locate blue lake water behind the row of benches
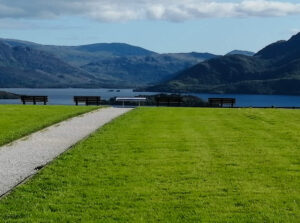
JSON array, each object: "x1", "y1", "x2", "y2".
[{"x1": 0, "y1": 88, "x2": 300, "y2": 107}]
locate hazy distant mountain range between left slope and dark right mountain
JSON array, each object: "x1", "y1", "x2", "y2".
[{"x1": 0, "y1": 39, "x2": 216, "y2": 88}]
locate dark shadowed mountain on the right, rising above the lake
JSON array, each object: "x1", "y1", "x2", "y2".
[{"x1": 146, "y1": 33, "x2": 300, "y2": 95}]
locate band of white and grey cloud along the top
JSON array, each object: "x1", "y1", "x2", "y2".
[{"x1": 0, "y1": 0, "x2": 300, "y2": 22}]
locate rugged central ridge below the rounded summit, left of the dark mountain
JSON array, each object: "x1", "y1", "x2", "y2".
[{"x1": 81, "y1": 53, "x2": 216, "y2": 86}]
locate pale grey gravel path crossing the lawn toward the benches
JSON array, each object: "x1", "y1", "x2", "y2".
[{"x1": 0, "y1": 108, "x2": 131, "y2": 197}]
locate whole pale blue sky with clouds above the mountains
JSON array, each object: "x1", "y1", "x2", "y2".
[{"x1": 0, "y1": 0, "x2": 300, "y2": 54}]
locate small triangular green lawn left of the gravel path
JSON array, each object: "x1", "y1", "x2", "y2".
[{"x1": 0, "y1": 105, "x2": 96, "y2": 146}]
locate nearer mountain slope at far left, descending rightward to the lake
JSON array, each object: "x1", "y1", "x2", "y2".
[{"x1": 0, "y1": 41, "x2": 115, "y2": 87}]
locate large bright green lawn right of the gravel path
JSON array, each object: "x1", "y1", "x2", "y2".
[{"x1": 0, "y1": 108, "x2": 300, "y2": 222}]
